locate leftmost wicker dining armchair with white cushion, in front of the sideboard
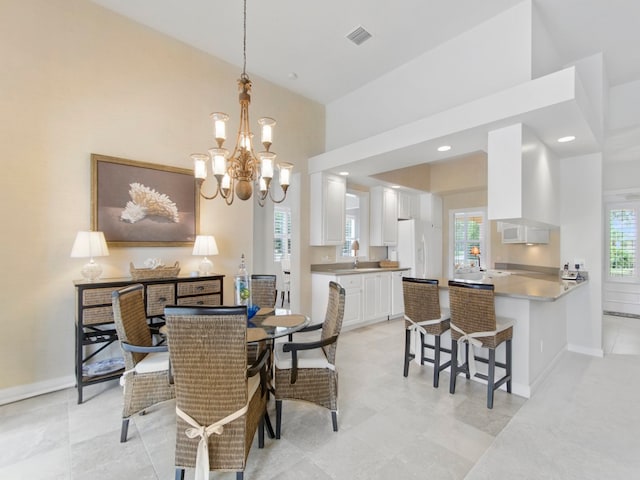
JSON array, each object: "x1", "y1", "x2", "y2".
[{"x1": 111, "y1": 283, "x2": 175, "y2": 442}]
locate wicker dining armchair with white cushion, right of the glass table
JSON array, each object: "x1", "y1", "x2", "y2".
[{"x1": 274, "y1": 282, "x2": 345, "y2": 438}]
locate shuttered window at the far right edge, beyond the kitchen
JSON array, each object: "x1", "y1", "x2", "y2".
[{"x1": 607, "y1": 204, "x2": 640, "y2": 279}]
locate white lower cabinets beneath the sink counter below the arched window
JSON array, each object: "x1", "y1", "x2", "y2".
[{"x1": 311, "y1": 272, "x2": 396, "y2": 330}]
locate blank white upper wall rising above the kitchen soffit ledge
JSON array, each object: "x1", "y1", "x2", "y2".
[{"x1": 326, "y1": 0, "x2": 532, "y2": 150}]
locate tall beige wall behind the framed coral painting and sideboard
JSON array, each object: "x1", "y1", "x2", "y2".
[{"x1": 0, "y1": 0, "x2": 324, "y2": 400}]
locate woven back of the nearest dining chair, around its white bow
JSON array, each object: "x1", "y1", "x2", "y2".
[{"x1": 165, "y1": 306, "x2": 250, "y2": 469}]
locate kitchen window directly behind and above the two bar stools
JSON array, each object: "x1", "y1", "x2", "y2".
[{"x1": 452, "y1": 210, "x2": 486, "y2": 268}]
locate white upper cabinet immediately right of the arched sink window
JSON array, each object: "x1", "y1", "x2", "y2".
[{"x1": 369, "y1": 187, "x2": 398, "y2": 247}]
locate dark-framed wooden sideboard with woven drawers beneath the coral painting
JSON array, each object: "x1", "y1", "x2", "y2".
[{"x1": 74, "y1": 274, "x2": 224, "y2": 403}]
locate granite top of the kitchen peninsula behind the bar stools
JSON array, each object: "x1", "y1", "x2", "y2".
[{"x1": 440, "y1": 271, "x2": 588, "y2": 302}]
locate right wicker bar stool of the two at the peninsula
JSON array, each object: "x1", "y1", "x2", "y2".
[{"x1": 449, "y1": 280, "x2": 513, "y2": 408}]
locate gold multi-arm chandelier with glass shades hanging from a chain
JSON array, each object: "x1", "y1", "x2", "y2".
[{"x1": 191, "y1": 0, "x2": 293, "y2": 207}]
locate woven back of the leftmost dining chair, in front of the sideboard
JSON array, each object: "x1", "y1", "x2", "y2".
[{"x1": 111, "y1": 283, "x2": 153, "y2": 370}]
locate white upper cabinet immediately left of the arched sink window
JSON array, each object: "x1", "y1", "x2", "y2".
[{"x1": 309, "y1": 172, "x2": 347, "y2": 246}]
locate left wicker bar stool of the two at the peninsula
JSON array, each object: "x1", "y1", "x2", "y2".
[{"x1": 402, "y1": 277, "x2": 451, "y2": 388}]
